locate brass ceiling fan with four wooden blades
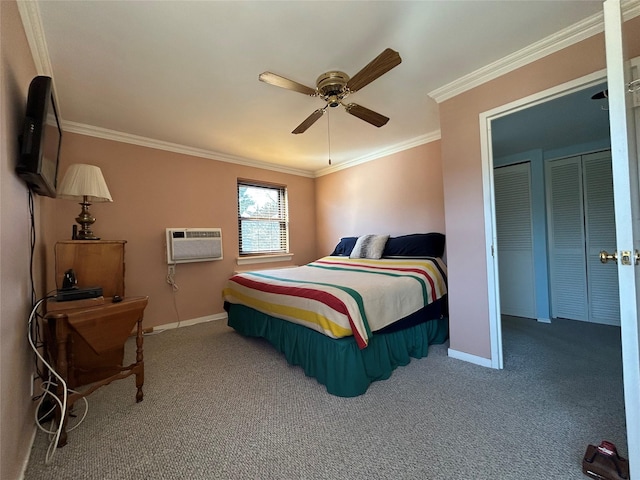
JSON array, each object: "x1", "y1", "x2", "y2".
[{"x1": 258, "y1": 48, "x2": 402, "y2": 134}]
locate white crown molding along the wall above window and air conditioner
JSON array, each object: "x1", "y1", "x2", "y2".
[{"x1": 61, "y1": 120, "x2": 314, "y2": 178}]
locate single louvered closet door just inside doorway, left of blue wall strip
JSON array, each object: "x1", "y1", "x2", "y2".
[{"x1": 493, "y1": 163, "x2": 536, "y2": 318}]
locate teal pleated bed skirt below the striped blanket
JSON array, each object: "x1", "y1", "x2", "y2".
[{"x1": 228, "y1": 304, "x2": 449, "y2": 397}]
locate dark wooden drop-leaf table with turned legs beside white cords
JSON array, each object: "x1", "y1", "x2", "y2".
[{"x1": 45, "y1": 297, "x2": 149, "y2": 447}]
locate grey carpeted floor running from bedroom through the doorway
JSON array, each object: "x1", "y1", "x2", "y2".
[{"x1": 25, "y1": 318, "x2": 627, "y2": 480}]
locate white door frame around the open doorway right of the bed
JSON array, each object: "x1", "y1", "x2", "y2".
[{"x1": 479, "y1": 69, "x2": 607, "y2": 369}]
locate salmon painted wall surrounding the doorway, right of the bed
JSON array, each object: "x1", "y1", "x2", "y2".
[{"x1": 440, "y1": 17, "x2": 640, "y2": 359}]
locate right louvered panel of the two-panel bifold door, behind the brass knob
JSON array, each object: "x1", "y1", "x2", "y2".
[{"x1": 582, "y1": 151, "x2": 620, "y2": 325}]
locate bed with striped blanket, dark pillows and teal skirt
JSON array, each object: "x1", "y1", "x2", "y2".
[{"x1": 222, "y1": 233, "x2": 448, "y2": 397}]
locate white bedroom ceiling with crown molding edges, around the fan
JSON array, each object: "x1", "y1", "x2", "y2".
[{"x1": 19, "y1": 0, "x2": 616, "y2": 175}]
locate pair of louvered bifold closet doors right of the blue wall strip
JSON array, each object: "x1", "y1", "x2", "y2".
[{"x1": 544, "y1": 150, "x2": 620, "y2": 326}]
